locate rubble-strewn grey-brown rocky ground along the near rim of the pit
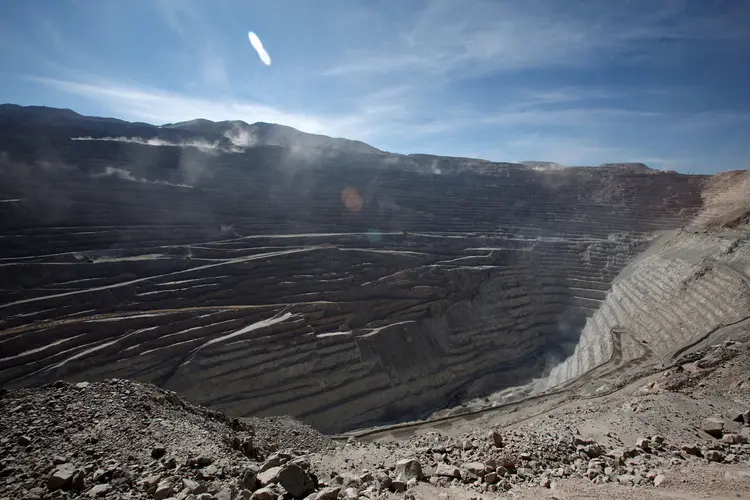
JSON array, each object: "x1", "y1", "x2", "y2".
[{"x1": 0, "y1": 329, "x2": 750, "y2": 500}]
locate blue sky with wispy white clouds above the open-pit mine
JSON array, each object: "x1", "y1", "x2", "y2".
[{"x1": 0, "y1": 0, "x2": 750, "y2": 172}]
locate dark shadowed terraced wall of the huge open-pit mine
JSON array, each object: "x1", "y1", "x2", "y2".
[{"x1": 0, "y1": 111, "x2": 704, "y2": 432}]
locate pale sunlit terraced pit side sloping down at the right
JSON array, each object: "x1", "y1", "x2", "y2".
[{"x1": 542, "y1": 171, "x2": 750, "y2": 389}]
